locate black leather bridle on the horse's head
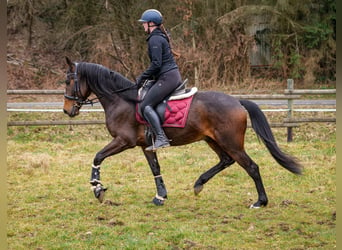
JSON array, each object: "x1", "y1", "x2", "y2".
[{"x1": 64, "y1": 63, "x2": 99, "y2": 108}]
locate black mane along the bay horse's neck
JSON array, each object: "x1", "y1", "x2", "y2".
[{"x1": 77, "y1": 62, "x2": 138, "y2": 102}]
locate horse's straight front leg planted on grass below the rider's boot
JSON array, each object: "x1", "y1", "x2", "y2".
[{"x1": 143, "y1": 149, "x2": 167, "y2": 206}]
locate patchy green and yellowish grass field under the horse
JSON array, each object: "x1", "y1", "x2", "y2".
[{"x1": 7, "y1": 112, "x2": 336, "y2": 249}]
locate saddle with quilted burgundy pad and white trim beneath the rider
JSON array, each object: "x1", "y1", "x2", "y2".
[{"x1": 136, "y1": 79, "x2": 197, "y2": 127}]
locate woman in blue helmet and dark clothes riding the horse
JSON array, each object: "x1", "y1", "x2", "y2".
[{"x1": 137, "y1": 9, "x2": 182, "y2": 151}]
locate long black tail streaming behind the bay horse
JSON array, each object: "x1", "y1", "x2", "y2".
[{"x1": 239, "y1": 100, "x2": 303, "y2": 174}]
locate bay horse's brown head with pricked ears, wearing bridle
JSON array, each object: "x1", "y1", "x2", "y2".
[{"x1": 63, "y1": 57, "x2": 91, "y2": 117}]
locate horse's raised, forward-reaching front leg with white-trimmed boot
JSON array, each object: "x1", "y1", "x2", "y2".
[{"x1": 90, "y1": 136, "x2": 135, "y2": 202}]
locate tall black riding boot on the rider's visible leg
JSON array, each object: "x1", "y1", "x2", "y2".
[{"x1": 144, "y1": 106, "x2": 170, "y2": 151}]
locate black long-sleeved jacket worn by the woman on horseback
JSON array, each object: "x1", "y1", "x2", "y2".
[{"x1": 138, "y1": 28, "x2": 178, "y2": 83}]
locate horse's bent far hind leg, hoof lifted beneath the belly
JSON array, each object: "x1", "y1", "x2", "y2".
[{"x1": 194, "y1": 139, "x2": 235, "y2": 195}]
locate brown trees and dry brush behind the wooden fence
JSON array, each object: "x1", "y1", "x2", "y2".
[{"x1": 7, "y1": 0, "x2": 336, "y2": 88}]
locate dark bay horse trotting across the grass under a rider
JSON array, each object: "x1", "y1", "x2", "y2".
[{"x1": 64, "y1": 58, "x2": 302, "y2": 208}]
